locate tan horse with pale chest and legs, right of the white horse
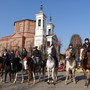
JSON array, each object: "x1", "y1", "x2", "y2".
[{"x1": 65, "y1": 50, "x2": 76, "y2": 84}]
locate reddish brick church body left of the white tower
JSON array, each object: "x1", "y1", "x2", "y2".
[{"x1": 0, "y1": 19, "x2": 36, "y2": 51}]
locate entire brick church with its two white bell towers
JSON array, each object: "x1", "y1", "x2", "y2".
[{"x1": 0, "y1": 5, "x2": 59, "y2": 58}]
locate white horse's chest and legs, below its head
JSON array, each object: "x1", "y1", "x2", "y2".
[{"x1": 46, "y1": 55, "x2": 57, "y2": 83}]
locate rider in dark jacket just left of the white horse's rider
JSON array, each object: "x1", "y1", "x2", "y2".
[{"x1": 32, "y1": 46, "x2": 42, "y2": 64}]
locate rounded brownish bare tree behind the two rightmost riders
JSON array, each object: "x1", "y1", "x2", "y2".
[{"x1": 70, "y1": 34, "x2": 82, "y2": 59}]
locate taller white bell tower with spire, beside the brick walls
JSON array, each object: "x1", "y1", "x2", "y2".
[{"x1": 34, "y1": 4, "x2": 46, "y2": 47}]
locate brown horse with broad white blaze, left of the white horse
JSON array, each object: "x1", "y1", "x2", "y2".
[{"x1": 22, "y1": 56, "x2": 46, "y2": 84}]
